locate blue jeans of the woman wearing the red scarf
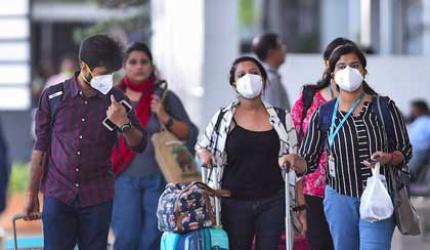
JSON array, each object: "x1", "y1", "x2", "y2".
[{"x1": 112, "y1": 174, "x2": 165, "y2": 250}]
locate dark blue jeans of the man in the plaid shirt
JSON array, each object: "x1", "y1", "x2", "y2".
[{"x1": 42, "y1": 196, "x2": 112, "y2": 250}]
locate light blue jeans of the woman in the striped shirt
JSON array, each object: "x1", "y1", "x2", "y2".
[{"x1": 324, "y1": 185, "x2": 395, "y2": 250}]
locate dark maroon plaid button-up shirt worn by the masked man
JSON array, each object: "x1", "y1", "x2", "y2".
[{"x1": 35, "y1": 74, "x2": 146, "y2": 207}]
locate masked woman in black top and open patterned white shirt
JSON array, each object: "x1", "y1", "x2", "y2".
[{"x1": 196, "y1": 56, "x2": 306, "y2": 250}]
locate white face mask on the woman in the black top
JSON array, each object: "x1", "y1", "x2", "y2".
[{"x1": 236, "y1": 74, "x2": 263, "y2": 99}]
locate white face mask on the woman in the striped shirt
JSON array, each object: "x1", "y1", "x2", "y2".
[{"x1": 334, "y1": 66, "x2": 364, "y2": 92}]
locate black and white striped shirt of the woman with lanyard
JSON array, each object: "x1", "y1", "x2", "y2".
[{"x1": 299, "y1": 97, "x2": 412, "y2": 197}]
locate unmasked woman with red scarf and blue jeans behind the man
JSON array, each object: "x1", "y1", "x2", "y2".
[{"x1": 112, "y1": 42, "x2": 197, "y2": 250}]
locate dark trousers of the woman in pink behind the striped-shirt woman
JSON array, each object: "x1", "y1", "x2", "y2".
[{"x1": 305, "y1": 195, "x2": 334, "y2": 250}]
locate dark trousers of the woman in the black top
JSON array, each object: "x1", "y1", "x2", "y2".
[{"x1": 222, "y1": 192, "x2": 285, "y2": 250}]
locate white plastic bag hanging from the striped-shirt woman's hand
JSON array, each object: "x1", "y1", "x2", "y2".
[{"x1": 360, "y1": 163, "x2": 394, "y2": 222}]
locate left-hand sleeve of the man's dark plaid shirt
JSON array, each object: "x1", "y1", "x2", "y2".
[{"x1": 34, "y1": 90, "x2": 51, "y2": 152}]
